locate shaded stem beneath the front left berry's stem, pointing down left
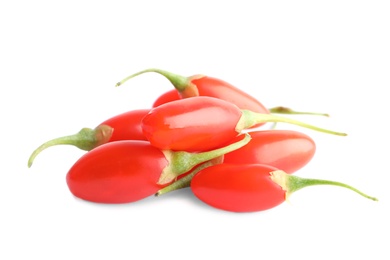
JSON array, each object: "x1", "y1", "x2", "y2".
[{"x1": 155, "y1": 156, "x2": 223, "y2": 196}]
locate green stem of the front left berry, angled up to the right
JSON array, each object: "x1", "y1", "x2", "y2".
[{"x1": 158, "y1": 134, "x2": 251, "y2": 184}]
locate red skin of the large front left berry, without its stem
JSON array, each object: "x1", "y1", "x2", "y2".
[{"x1": 66, "y1": 140, "x2": 168, "y2": 203}]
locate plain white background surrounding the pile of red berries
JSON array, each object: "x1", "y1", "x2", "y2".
[{"x1": 0, "y1": 0, "x2": 390, "y2": 260}]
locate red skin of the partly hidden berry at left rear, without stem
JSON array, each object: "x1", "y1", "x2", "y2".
[{"x1": 100, "y1": 109, "x2": 150, "y2": 142}]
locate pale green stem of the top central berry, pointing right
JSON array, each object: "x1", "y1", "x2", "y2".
[{"x1": 236, "y1": 109, "x2": 347, "y2": 136}]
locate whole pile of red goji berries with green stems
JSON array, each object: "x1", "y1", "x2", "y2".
[{"x1": 28, "y1": 69, "x2": 377, "y2": 212}]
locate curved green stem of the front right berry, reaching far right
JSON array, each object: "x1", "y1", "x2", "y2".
[{"x1": 271, "y1": 171, "x2": 378, "y2": 201}]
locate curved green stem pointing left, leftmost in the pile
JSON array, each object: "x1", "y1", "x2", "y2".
[{"x1": 28, "y1": 125, "x2": 113, "y2": 167}]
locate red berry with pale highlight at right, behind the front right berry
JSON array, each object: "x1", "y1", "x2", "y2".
[{"x1": 224, "y1": 130, "x2": 316, "y2": 174}]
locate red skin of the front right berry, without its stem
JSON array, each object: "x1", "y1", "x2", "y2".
[{"x1": 191, "y1": 163, "x2": 286, "y2": 212}]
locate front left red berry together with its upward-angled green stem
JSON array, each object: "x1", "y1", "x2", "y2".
[{"x1": 66, "y1": 135, "x2": 250, "y2": 203}]
